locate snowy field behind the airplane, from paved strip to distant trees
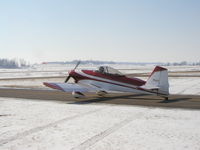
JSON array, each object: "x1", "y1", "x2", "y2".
[{"x1": 0, "y1": 64, "x2": 200, "y2": 95}]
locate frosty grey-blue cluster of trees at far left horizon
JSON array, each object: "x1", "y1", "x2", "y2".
[{"x1": 0, "y1": 58, "x2": 29, "y2": 69}]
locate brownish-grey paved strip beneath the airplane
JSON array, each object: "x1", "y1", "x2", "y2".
[{"x1": 0, "y1": 89, "x2": 200, "y2": 109}]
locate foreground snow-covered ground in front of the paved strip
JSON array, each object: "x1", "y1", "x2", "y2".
[{"x1": 0, "y1": 98, "x2": 200, "y2": 150}]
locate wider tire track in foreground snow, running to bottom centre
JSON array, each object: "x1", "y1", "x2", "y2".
[{"x1": 71, "y1": 113, "x2": 142, "y2": 150}]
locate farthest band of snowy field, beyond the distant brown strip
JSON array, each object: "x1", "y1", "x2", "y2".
[{"x1": 0, "y1": 64, "x2": 200, "y2": 79}]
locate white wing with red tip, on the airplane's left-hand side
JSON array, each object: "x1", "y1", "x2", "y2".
[{"x1": 43, "y1": 82, "x2": 96, "y2": 92}]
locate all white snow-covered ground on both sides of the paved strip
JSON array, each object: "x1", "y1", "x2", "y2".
[{"x1": 0, "y1": 65, "x2": 200, "y2": 150}]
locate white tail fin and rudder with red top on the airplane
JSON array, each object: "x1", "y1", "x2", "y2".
[{"x1": 145, "y1": 66, "x2": 169, "y2": 95}]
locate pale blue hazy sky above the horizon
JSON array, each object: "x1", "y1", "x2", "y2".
[{"x1": 0, "y1": 0, "x2": 200, "y2": 62}]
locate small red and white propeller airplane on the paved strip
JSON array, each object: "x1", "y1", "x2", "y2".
[{"x1": 43, "y1": 61, "x2": 169, "y2": 100}]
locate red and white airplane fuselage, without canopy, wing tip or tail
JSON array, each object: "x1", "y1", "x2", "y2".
[{"x1": 69, "y1": 70, "x2": 152, "y2": 93}]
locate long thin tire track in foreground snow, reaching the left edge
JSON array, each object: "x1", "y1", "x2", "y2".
[{"x1": 0, "y1": 107, "x2": 106, "y2": 146}]
